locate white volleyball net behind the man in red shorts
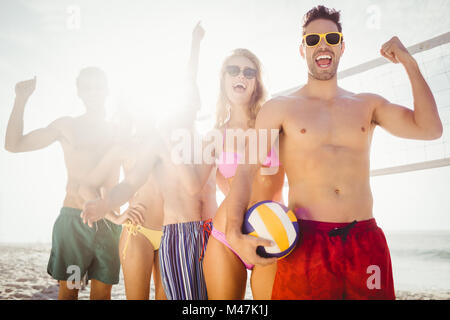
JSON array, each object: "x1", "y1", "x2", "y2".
[{"x1": 277, "y1": 32, "x2": 450, "y2": 176}]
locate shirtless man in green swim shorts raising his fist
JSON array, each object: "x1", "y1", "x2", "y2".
[{"x1": 5, "y1": 67, "x2": 125, "y2": 300}]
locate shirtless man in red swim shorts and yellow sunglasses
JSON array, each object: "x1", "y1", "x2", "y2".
[{"x1": 226, "y1": 6, "x2": 442, "y2": 299}]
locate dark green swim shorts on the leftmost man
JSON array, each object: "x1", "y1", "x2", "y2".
[{"x1": 47, "y1": 207, "x2": 122, "y2": 284}]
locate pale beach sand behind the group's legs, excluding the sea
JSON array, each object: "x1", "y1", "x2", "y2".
[{"x1": 0, "y1": 244, "x2": 450, "y2": 300}]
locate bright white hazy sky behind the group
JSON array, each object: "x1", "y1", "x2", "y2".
[{"x1": 0, "y1": 0, "x2": 450, "y2": 242}]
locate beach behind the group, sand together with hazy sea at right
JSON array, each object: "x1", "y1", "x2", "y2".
[{"x1": 0, "y1": 231, "x2": 450, "y2": 300}]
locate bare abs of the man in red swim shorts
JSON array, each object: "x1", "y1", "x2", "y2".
[{"x1": 285, "y1": 147, "x2": 373, "y2": 222}]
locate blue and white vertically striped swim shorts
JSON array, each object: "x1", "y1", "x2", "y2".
[{"x1": 159, "y1": 220, "x2": 212, "y2": 300}]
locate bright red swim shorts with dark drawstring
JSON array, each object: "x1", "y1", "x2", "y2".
[{"x1": 272, "y1": 219, "x2": 395, "y2": 300}]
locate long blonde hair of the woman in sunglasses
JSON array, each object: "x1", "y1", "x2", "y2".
[{"x1": 215, "y1": 48, "x2": 267, "y2": 128}]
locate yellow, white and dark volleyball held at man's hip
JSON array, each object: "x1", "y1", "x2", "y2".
[{"x1": 242, "y1": 201, "x2": 299, "y2": 259}]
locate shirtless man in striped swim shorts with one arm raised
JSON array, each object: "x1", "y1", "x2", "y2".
[{"x1": 82, "y1": 24, "x2": 217, "y2": 300}]
